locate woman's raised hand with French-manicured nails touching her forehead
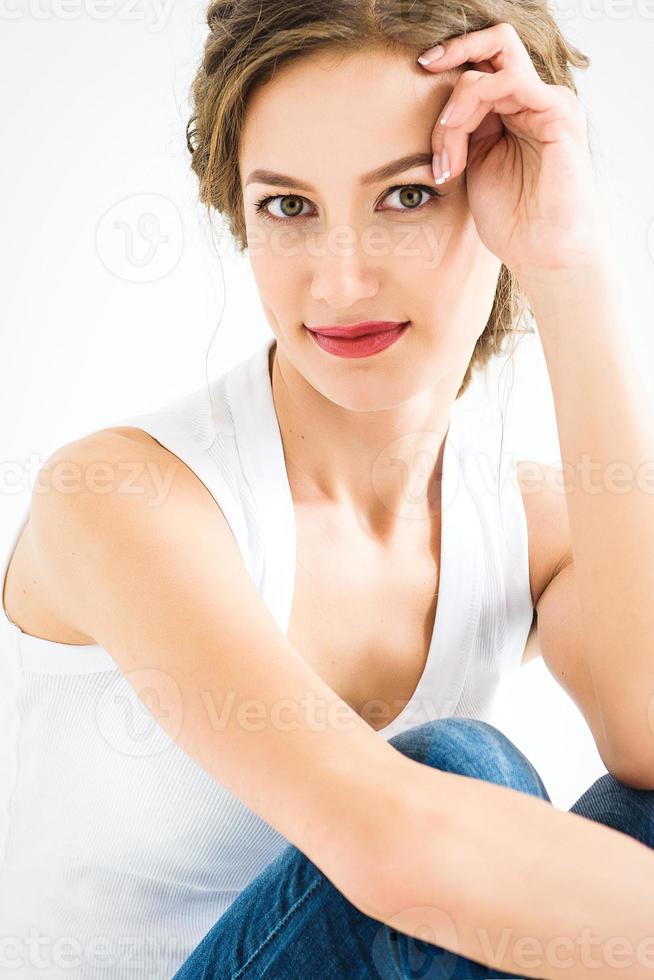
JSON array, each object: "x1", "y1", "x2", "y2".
[{"x1": 420, "y1": 23, "x2": 601, "y2": 279}]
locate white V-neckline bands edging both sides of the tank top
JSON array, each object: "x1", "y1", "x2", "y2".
[{"x1": 227, "y1": 337, "x2": 482, "y2": 738}]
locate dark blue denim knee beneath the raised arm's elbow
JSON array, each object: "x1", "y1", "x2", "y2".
[{"x1": 570, "y1": 772, "x2": 654, "y2": 847}]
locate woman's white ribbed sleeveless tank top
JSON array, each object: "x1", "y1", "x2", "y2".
[{"x1": 0, "y1": 338, "x2": 533, "y2": 980}]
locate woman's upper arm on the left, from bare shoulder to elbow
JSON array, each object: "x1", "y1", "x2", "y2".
[{"x1": 30, "y1": 431, "x2": 403, "y2": 908}]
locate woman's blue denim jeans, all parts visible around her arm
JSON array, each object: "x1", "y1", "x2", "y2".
[{"x1": 173, "y1": 717, "x2": 654, "y2": 980}]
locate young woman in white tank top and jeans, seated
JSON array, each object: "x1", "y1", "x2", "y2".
[{"x1": 0, "y1": 0, "x2": 654, "y2": 980}]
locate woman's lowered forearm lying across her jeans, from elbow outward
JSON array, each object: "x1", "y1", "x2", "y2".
[{"x1": 376, "y1": 759, "x2": 654, "y2": 980}]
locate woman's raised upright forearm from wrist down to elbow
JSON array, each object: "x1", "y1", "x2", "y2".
[{"x1": 521, "y1": 255, "x2": 654, "y2": 789}]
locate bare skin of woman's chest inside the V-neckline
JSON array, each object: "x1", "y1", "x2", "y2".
[{"x1": 287, "y1": 512, "x2": 440, "y2": 730}]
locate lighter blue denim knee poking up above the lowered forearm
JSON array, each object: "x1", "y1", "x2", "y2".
[{"x1": 389, "y1": 717, "x2": 551, "y2": 802}]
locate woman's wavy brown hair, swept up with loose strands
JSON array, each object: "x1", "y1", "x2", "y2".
[{"x1": 186, "y1": 0, "x2": 590, "y2": 398}]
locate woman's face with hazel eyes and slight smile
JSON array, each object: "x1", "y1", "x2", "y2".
[{"x1": 239, "y1": 50, "x2": 501, "y2": 411}]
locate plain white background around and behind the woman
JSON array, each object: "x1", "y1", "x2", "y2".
[{"x1": 0, "y1": 0, "x2": 654, "y2": 807}]
